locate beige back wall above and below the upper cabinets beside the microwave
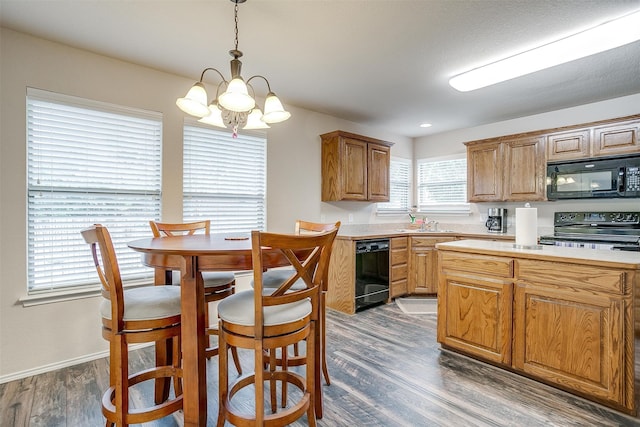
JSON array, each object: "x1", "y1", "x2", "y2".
[{"x1": 414, "y1": 93, "x2": 640, "y2": 231}]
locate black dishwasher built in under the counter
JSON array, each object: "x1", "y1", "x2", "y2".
[{"x1": 356, "y1": 239, "x2": 389, "y2": 311}]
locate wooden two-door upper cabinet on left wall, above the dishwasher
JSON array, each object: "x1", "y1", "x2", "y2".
[{"x1": 320, "y1": 131, "x2": 393, "y2": 202}]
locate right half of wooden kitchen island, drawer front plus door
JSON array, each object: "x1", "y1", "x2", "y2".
[{"x1": 513, "y1": 260, "x2": 633, "y2": 407}]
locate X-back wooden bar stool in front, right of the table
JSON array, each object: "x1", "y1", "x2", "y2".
[{"x1": 218, "y1": 229, "x2": 338, "y2": 427}]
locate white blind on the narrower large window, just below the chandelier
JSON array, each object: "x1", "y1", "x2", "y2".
[{"x1": 183, "y1": 125, "x2": 267, "y2": 233}]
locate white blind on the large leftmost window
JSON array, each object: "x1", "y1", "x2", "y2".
[{"x1": 27, "y1": 89, "x2": 162, "y2": 293}]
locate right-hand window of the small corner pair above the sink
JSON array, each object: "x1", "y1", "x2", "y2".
[{"x1": 418, "y1": 154, "x2": 470, "y2": 213}]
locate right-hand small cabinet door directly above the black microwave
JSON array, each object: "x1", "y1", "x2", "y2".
[{"x1": 592, "y1": 121, "x2": 640, "y2": 156}]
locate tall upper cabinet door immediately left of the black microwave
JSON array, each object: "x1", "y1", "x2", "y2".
[{"x1": 503, "y1": 137, "x2": 546, "y2": 201}]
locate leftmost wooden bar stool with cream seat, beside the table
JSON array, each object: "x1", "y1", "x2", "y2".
[{"x1": 82, "y1": 224, "x2": 182, "y2": 427}]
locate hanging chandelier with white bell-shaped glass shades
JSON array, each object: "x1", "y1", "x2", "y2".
[{"x1": 176, "y1": 0, "x2": 291, "y2": 138}]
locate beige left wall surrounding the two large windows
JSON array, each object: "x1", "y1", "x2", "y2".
[{"x1": 0, "y1": 28, "x2": 413, "y2": 382}]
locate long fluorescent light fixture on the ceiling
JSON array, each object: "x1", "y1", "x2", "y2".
[{"x1": 449, "y1": 11, "x2": 640, "y2": 92}]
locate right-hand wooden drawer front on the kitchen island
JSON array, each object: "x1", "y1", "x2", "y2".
[{"x1": 516, "y1": 259, "x2": 631, "y2": 294}]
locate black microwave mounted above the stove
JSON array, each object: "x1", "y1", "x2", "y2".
[{"x1": 547, "y1": 156, "x2": 640, "y2": 200}]
